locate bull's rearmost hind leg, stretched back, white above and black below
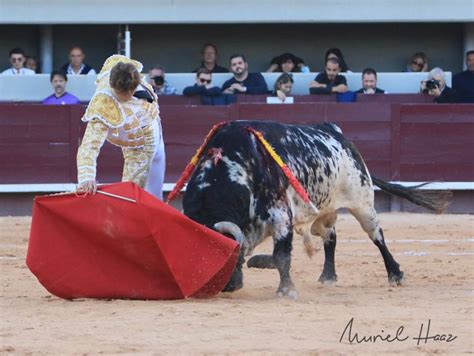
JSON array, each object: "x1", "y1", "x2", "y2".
[{"x1": 350, "y1": 207, "x2": 403, "y2": 285}]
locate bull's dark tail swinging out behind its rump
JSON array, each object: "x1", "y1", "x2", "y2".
[{"x1": 372, "y1": 176, "x2": 453, "y2": 214}]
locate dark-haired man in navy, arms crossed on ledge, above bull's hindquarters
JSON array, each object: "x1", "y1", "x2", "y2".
[{"x1": 309, "y1": 58, "x2": 347, "y2": 94}]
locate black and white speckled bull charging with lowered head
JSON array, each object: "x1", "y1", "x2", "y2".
[{"x1": 183, "y1": 121, "x2": 446, "y2": 298}]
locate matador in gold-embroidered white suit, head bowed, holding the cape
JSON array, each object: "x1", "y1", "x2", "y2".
[{"x1": 77, "y1": 55, "x2": 165, "y2": 199}]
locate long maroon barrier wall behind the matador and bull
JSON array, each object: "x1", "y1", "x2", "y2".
[{"x1": 0, "y1": 97, "x2": 474, "y2": 184}]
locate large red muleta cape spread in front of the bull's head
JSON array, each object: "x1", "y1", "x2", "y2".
[{"x1": 26, "y1": 182, "x2": 239, "y2": 299}]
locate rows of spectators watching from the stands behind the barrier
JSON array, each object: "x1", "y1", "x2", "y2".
[{"x1": 2, "y1": 43, "x2": 474, "y2": 105}]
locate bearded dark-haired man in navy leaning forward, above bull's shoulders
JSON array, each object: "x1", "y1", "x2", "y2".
[{"x1": 222, "y1": 54, "x2": 268, "y2": 94}]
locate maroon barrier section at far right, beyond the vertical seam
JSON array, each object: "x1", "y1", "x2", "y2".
[{"x1": 400, "y1": 105, "x2": 474, "y2": 181}]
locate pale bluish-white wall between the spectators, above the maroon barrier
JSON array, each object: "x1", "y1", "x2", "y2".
[{"x1": 0, "y1": 72, "x2": 452, "y2": 101}]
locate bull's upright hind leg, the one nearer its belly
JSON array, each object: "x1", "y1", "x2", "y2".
[{"x1": 311, "y1": 212, "x2": 337, "y2": 284}]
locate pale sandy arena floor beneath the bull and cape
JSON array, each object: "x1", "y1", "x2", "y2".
[{"x1": 0, "y1": 214, "x2": 474, "y2": 355}]
